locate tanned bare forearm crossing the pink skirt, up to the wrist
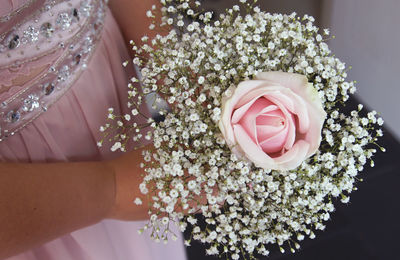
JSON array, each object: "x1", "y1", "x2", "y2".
[{"x1": 0, "y1": 162, "x2": 115, "y2": 259}]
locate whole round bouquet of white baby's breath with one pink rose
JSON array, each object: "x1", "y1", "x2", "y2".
[{"x1": 102, "y1": 0, "x2": 383, "y2": 259}]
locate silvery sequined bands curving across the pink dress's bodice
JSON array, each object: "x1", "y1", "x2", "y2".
[{"x1": 0, "y1": 0, "x2": 106, "y2": 141}]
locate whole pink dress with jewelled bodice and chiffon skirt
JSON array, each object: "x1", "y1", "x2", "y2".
[{"x1": 0, "y1": 0, "x2": 186, "y2": 260}]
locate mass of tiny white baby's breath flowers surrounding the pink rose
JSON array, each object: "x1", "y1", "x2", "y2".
[{"x1": 101, "y1": 0, "x2": 383, "y2": 259}]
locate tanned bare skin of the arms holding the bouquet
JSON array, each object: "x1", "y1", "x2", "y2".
[{"x1": 0, "y1": 0, "x2": 162, "y2": 259}]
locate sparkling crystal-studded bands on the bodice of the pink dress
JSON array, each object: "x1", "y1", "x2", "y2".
[{"x1": 0, "y1": 0, "x2": 105, "y2": 136}]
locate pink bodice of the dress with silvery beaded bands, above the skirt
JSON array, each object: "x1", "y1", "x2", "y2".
[{"x1": 0, "y1": 0, "x2": 106, "y2": 140}]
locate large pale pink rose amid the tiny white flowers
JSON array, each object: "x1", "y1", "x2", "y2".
[{"x1": 219, "y1": 72, "x2": 326, "y2": 170}]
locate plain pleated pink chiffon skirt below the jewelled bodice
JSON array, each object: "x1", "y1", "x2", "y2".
[{"x1": 0, "y1": 1, "x2": 186, "y2": 260}]
